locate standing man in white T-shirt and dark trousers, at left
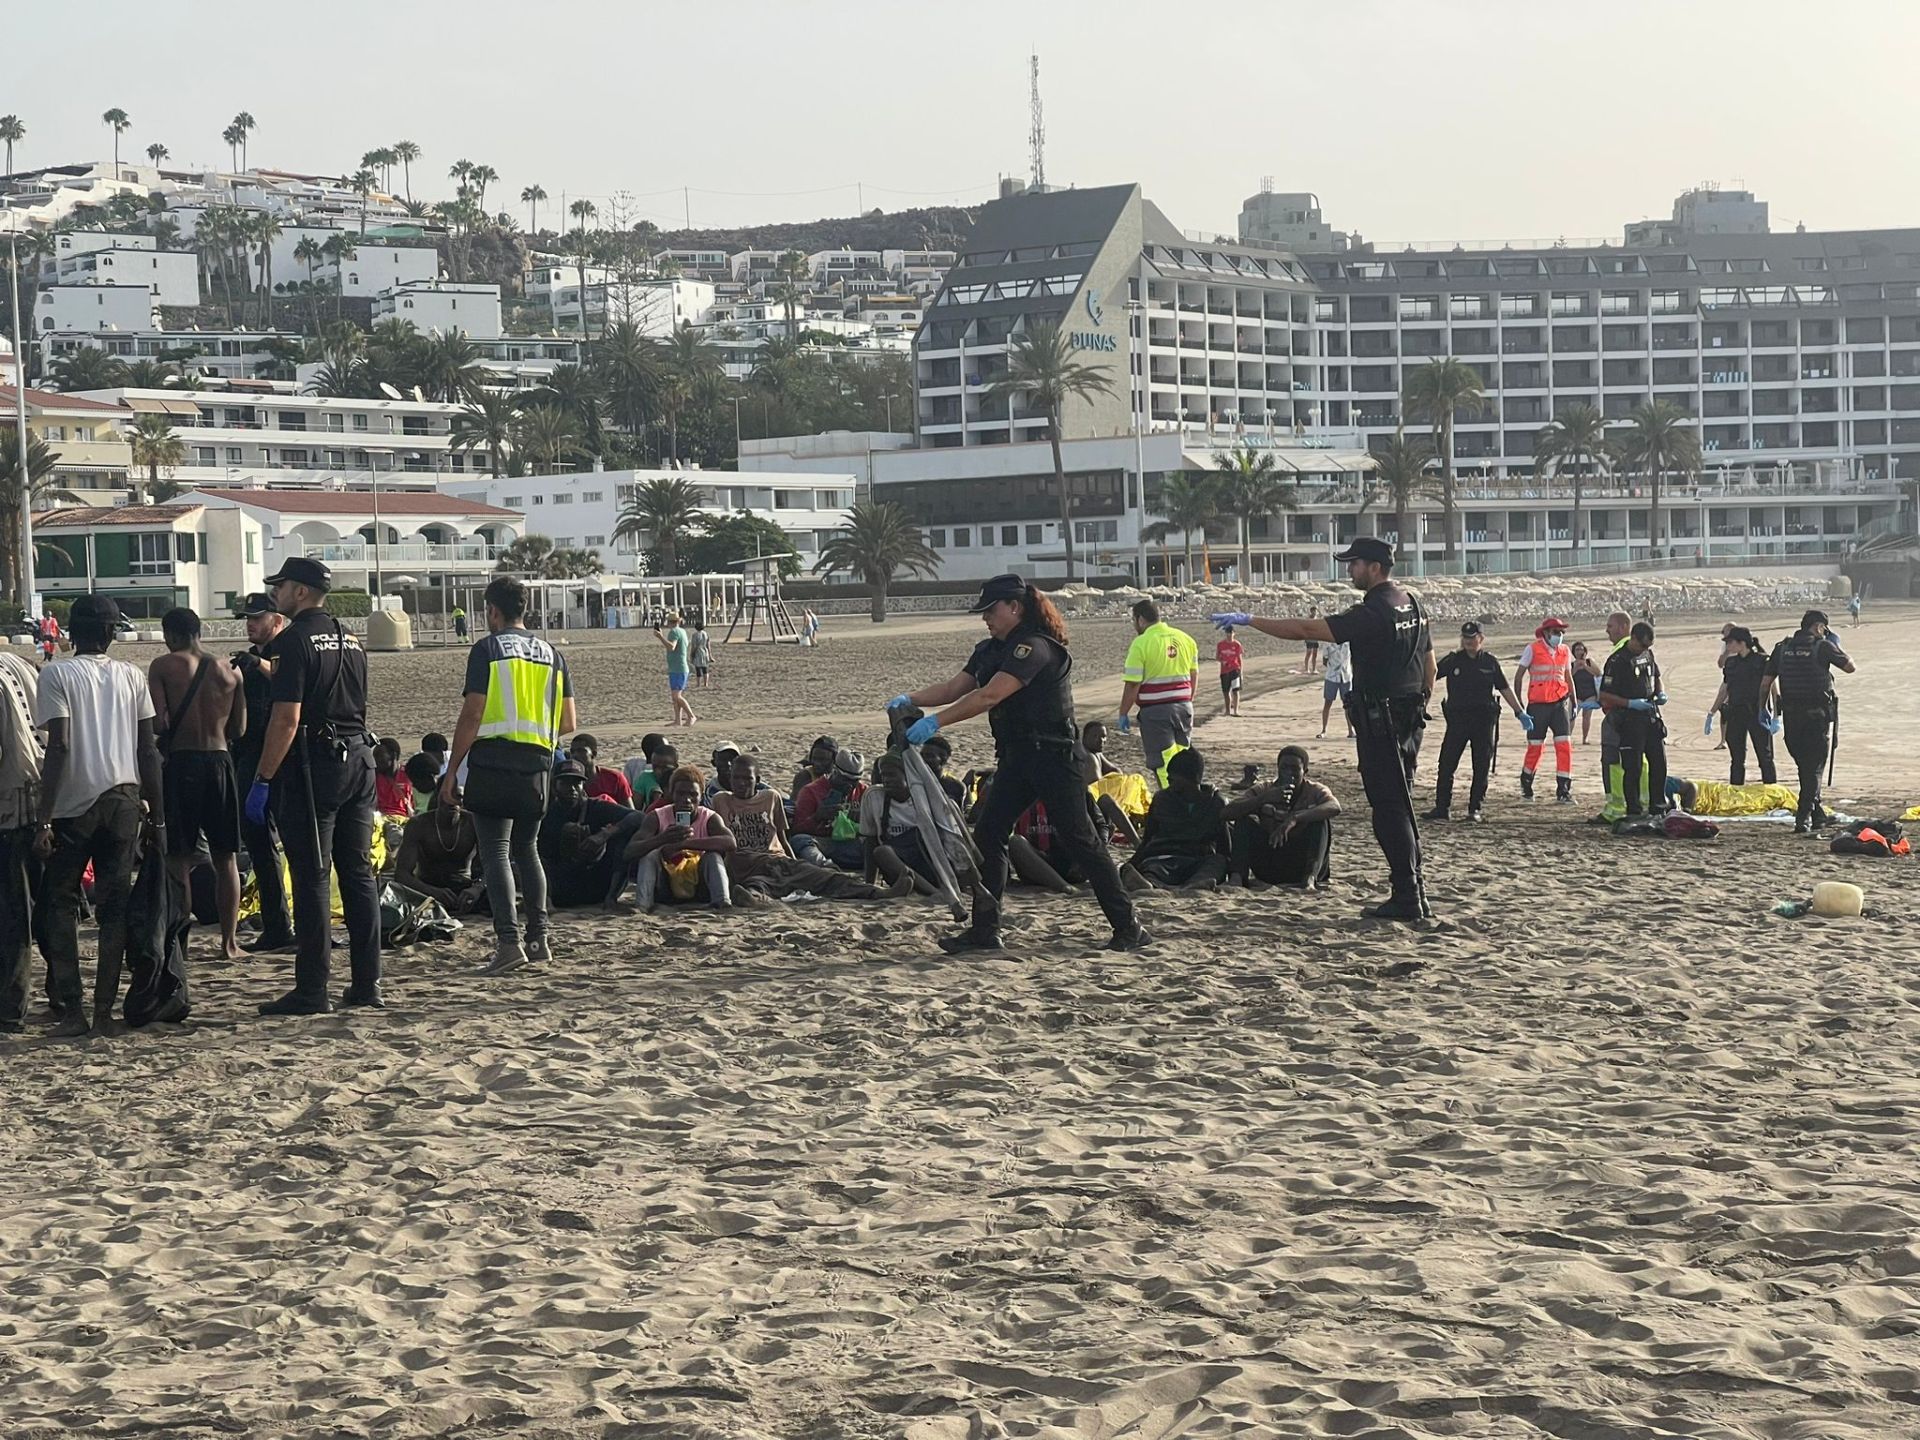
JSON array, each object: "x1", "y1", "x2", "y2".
[{"x1": 33, "y1": 595, "x2": 167, "y2": 1037}]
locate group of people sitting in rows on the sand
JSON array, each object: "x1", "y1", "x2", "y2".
[{"x1": 374, "y1": 722, "x2": 1340, "y2": 916}]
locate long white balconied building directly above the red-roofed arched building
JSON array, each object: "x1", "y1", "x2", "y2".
[{"x1": 88, "y1": 382, "x2": 486, "y2": 486}]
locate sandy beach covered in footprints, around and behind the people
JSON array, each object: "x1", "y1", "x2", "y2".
[{"x1": 0, "y1": 605, "x2": 1920, "y2": 1440}]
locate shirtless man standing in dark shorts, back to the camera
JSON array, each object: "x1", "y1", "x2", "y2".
[{"x1": 146, "y1": 607, "x2": 246, "y2": 960}]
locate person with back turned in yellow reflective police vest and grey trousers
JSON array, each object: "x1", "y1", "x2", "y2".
[{"x1": 440, "y1": 576, "x2": 576, "y2": 975}]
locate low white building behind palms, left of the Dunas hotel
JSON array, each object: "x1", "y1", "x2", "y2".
[{"x1": 442, "y1": 470, "x2": 856, "y2": 574}]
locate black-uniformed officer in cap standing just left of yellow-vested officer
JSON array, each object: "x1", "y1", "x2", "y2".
[{"x1": 246, "y1": 555, "x2": 384, "y2": 1016}]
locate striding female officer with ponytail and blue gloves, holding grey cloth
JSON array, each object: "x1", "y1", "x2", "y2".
[{"x1": 887, "y1": 574, "x2": 1150, "y2": 954}]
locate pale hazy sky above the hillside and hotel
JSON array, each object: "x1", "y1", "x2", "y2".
[{"x1": 15, "y1": 0, "x2": 1920, "y2": 240}]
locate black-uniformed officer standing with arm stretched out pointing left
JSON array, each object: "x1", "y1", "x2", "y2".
[{"x1": 1213, "y1": 536, "x2": 1436, "y2": 920}]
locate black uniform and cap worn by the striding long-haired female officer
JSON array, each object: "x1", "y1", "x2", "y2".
[{"x1": 944, "y1": 576, "x2": 1139, "y2": 943}]
